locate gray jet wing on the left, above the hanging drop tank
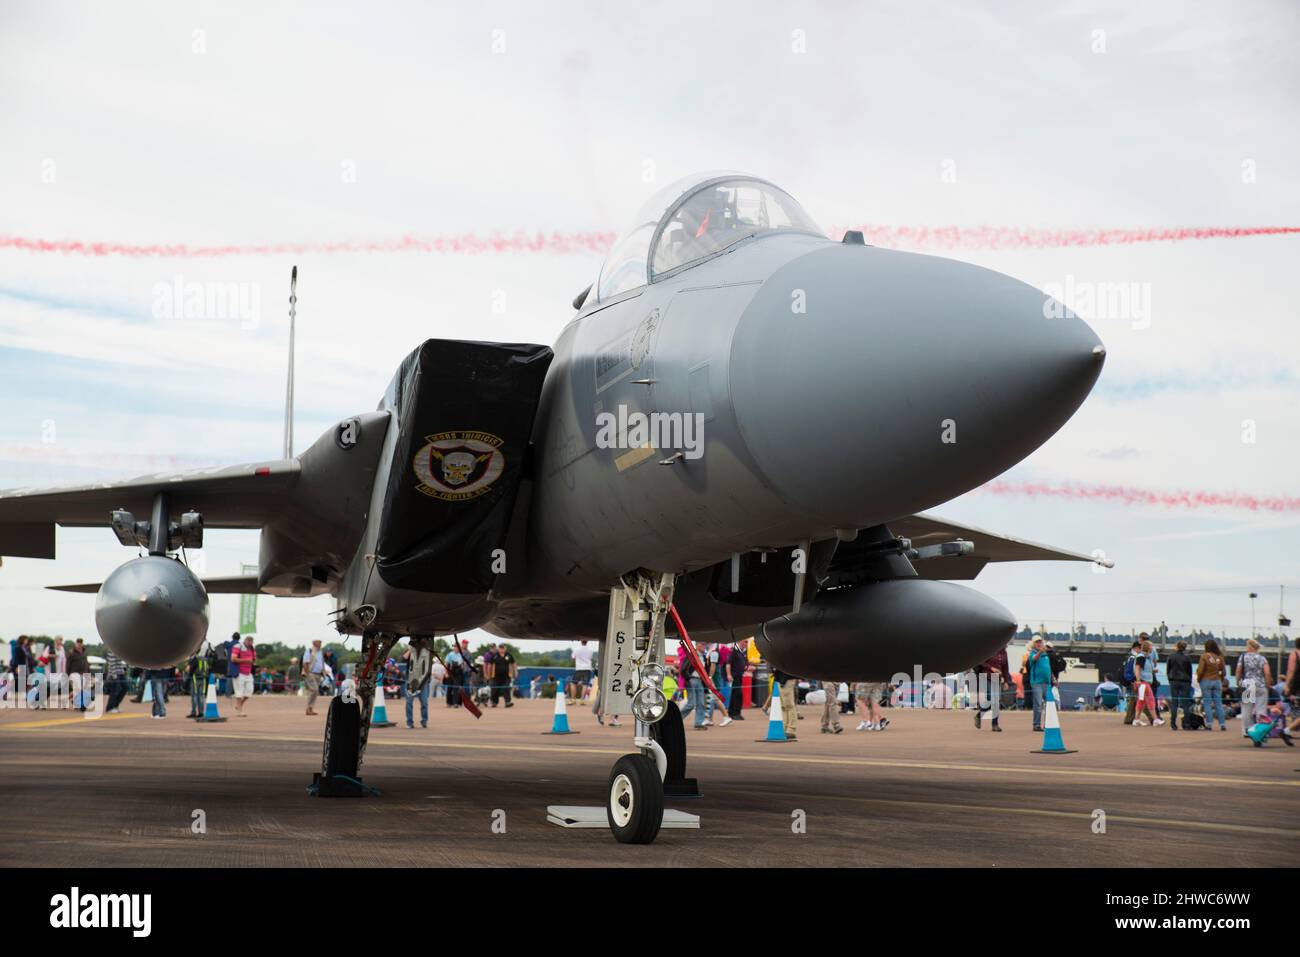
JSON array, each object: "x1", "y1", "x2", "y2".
[{"x1": 0, "y1": 459, "x2": 300, "y2": 556}]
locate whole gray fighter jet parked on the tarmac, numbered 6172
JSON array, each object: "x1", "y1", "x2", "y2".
[{"x1": 0, "y1": 172, "x2": 1105, "y2": 843}]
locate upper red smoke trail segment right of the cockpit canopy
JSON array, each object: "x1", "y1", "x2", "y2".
[{"x1": 831, "y1": 226, "x2": 1300, "y2": 250}]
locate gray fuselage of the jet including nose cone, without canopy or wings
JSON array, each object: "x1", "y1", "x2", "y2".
[{"x1": 340, "y1": 231, "x2": 1101, "y2": 637}]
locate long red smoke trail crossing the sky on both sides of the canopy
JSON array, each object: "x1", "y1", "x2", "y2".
[{"x1": 0, "y1": 226, "x2": 1300, "y2": 259}]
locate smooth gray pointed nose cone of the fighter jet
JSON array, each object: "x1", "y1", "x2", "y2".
[{"x1": 731, "y1": 244, "x2": 1105, "y2": 527}]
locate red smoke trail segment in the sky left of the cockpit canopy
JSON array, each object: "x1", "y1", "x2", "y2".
[{"x1": 0, "y1": 233, "x2": 616, "y2": 259}]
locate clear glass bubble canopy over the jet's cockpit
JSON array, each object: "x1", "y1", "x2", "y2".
[{"x1": 592, "y1": 173, "x2": 823, "y2": 302}]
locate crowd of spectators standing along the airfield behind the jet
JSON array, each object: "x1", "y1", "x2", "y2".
[{"x1": 0, "y1": 632, "x2": 1300, "y2": 745}]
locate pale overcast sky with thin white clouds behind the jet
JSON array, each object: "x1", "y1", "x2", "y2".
[{"x1": 0, "y1": 0, "x2": 1300, "y2": 642}]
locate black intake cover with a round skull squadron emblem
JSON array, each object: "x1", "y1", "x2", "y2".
[{"x1": 377, "y1": 339, "x2": 554, "y2": 594}]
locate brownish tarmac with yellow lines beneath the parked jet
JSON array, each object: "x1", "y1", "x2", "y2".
[{"x1": 0, "y1": 696, "x2": 1300, "y2": 867}]
